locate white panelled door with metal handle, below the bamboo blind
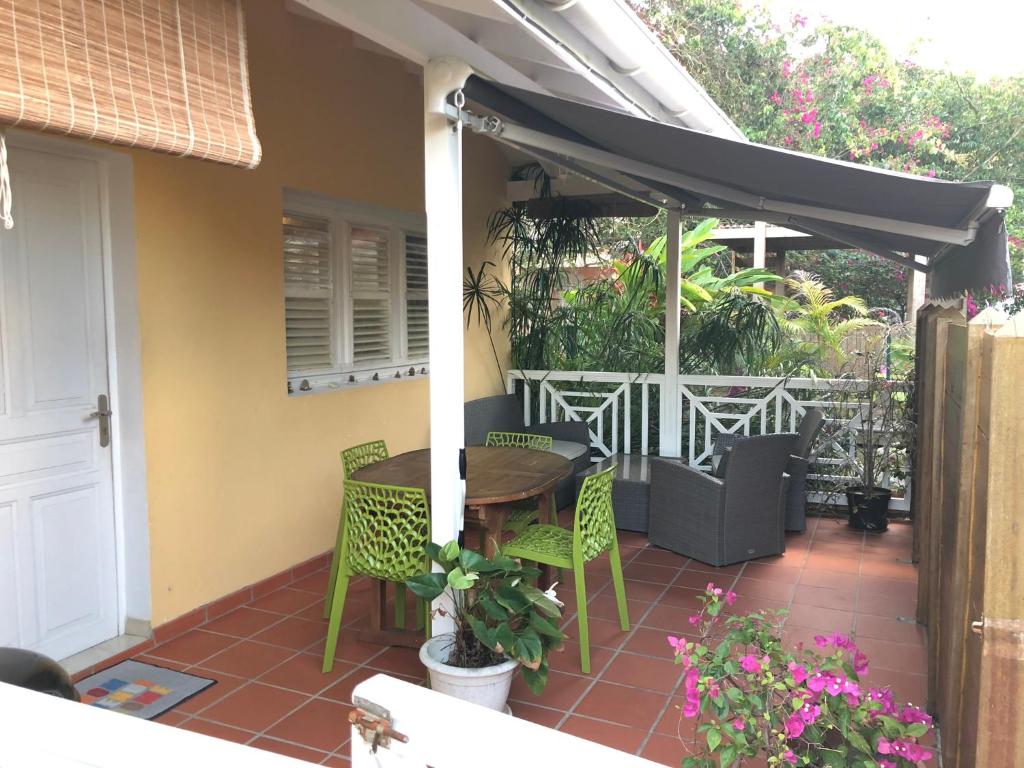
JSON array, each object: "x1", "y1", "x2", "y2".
[{"x1": 0, "y1": 147, "x2": 118, "y2": 658}]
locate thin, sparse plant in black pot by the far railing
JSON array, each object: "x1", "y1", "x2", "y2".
[{"x1": 834, "y1": 323, "x2": 913, "y2": 532}]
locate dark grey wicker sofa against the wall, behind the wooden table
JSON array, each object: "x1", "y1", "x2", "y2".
[{"x1": 465, "y1": 394, "x2": 590, "y2": 509}]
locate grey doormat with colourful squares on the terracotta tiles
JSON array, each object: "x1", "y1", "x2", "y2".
[{"x1": 75, "y1": 660, "x2": 216, "y2": 720}]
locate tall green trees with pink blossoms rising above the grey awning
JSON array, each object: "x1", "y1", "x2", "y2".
[{"x1": 631, "y1": 0, "x2": 1024, "y2": 282}]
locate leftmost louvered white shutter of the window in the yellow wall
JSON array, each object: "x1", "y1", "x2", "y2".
[{"x1": 283, "y1": 213, "x2": 334, "y2": 373}]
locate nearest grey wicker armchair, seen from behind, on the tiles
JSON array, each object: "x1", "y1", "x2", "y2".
[{"x1": 648, "y1": 434, "x2": 797, "y2": 565}]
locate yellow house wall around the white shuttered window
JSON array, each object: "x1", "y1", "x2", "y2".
[{"x1": 132, "y1": 0, "x2": 507, "y2": 626}]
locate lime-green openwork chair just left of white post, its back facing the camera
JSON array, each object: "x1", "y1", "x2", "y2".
[{"x1": 324, "y1": 480, "x2": 430, "y2": 674}]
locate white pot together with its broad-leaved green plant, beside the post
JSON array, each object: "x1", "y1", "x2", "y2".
[{"x1": 406, "y1": 542, "x2": 565, "y2": 711}]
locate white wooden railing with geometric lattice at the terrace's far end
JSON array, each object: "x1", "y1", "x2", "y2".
[{"x1": 506, "y1": 370, "x2": 910, "y2": 511}]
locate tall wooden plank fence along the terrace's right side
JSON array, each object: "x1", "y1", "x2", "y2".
[{"x1": 913, "y1": 307, "x2": 1024, "y2": 768}]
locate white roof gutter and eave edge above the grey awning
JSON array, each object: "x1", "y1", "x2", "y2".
[{"x1": 494, "y1": 0, "x2": 746, "y2": 140}]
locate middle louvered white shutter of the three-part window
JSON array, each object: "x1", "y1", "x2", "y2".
[{"x1": 349, "y1": 226, "x2": 392, "y2": 364}]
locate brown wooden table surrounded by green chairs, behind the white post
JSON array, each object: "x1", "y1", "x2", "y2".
[{"x1": 352, "y1": 445, "x2": 572, "y2": 557}]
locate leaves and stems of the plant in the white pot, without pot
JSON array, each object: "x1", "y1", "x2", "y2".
[{"x1": 406, "y1": 542, "x2": 565, "y2": 693}]
